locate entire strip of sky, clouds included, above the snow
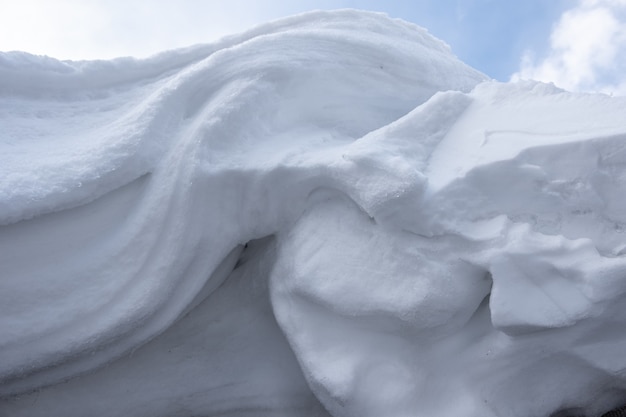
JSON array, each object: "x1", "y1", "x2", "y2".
[{"x1": 0, "y1": 0, "x2": 626, "y2": 94}]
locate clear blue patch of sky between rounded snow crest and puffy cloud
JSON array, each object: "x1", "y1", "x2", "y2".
[{"x1": 326, "y1": 0, "x2": 572, "y2": 81}]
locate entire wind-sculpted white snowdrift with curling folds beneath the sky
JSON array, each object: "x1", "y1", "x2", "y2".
[{"x1": 0, "y1": 11, "x2": 626, "y2": 417}]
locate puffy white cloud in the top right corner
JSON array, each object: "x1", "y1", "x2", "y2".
[{"x1": 511, "y1": 0, "x2": 626, "y2": 95}]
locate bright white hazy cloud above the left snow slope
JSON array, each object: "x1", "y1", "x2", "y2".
[{"x1": 0, "y1": 0, "x2": 277, "y2": 59}]
